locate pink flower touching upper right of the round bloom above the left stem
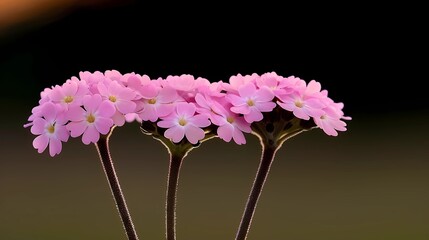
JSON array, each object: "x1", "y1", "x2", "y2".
[{"x1": 98, "y1": 81, "x2": 136, "y2": 126}]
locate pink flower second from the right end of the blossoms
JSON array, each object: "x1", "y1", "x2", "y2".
[{"x1": 277, "y1": 81, "x2": 325, "y2": 120}]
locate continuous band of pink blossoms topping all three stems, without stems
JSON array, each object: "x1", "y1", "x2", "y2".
[{"x1": 25, "y1": 70, "x2": 350, "y2": 156}]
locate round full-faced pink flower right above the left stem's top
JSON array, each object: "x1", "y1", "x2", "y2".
[{"x1": 67, "y1": 94, "x2": 115, "y2": 145}]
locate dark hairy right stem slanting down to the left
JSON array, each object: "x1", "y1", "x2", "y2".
[{"x1": 235, "y1": 141, "x2": 278, "y2": 240}]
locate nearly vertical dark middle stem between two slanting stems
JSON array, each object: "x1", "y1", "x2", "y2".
[{"x1": 165, "y1": 153, "x2": 184, "y2": 240}]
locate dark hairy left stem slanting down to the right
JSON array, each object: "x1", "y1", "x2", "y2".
[{"x1": 95, "y1": 132, "x2": 138, "y2": 240}]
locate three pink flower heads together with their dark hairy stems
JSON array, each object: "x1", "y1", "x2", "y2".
[{"x1": 25, "y1": 70, "x2": 351, "y2": 239}]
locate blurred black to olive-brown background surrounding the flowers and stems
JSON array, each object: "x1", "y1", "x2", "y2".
[{"x1": 0, "y1": 0, "x2": 429, "y2": 240}]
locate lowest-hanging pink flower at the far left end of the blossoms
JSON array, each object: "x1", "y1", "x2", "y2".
[{"x1": 31, "y1": 102, "x2": 69, "y2": 157}]
